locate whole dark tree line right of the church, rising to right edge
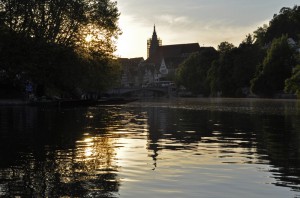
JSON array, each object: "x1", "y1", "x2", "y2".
[{"x1": 177, "y1": 6, "x2": 300, "y2": 97}]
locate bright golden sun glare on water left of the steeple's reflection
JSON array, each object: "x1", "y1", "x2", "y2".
[{"x1": 56, "y1": 106, "x2": 153, "y2": 186}]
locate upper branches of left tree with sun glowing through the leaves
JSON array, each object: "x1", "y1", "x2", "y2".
[{"x1": 0, "y1": 0, "x2": 120, "y2": 54}]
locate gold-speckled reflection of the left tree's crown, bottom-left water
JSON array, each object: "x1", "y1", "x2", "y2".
[{"x1": 0, "y1": 138, "x2": 119, "y2": 197}]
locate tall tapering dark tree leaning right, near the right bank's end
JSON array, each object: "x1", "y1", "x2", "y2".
[{"x1": 251, "y1": 35, "x2": 295, "y2": 97}]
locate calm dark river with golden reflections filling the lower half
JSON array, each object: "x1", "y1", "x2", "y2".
[{"x1": 0, "y1": 99, "x2": 300, "y2": 198}]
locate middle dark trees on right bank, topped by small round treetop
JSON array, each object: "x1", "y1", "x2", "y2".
[{"x1": 208, "y1": 38, "x2": 264, "y2": 97}]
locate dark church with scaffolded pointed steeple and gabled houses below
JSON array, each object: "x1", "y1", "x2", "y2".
[{"x1": 120, "y1": 25, "x2": 212, "y2": 87}]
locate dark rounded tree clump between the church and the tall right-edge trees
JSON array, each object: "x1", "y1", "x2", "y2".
[{"x1": 177, "y1": 35, "x2": 264, "y2": 97}]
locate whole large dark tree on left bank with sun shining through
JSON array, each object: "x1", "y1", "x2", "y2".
[{"x1": 0, "y1": 0, "x2": 120, "y2": 96}]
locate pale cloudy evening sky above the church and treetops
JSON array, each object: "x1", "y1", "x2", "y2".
[{"x1": 115, "y1": 0, "x2": 300, "y2": 58}]
